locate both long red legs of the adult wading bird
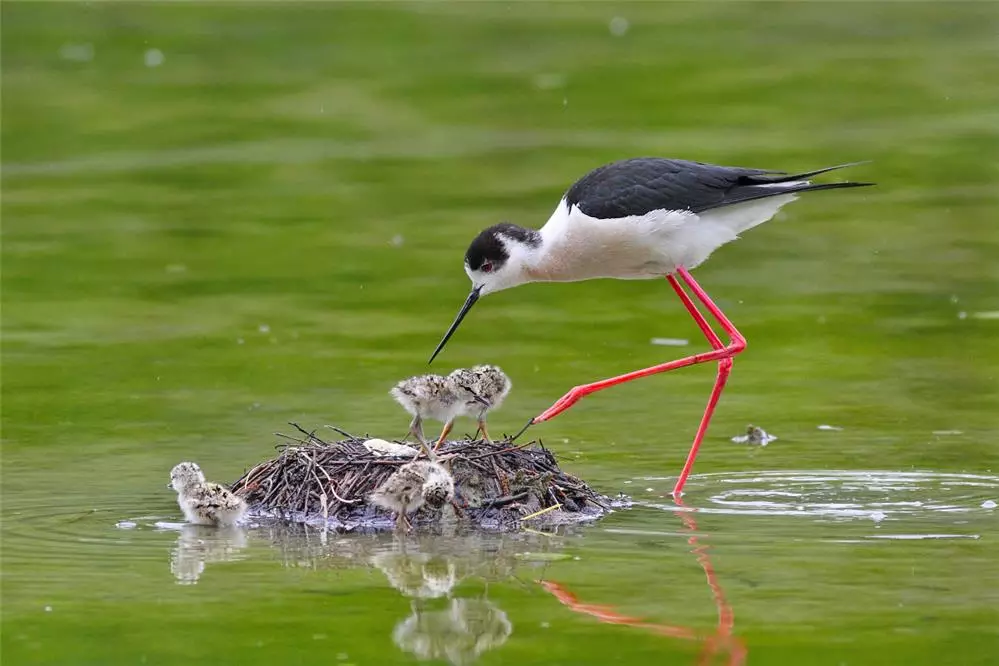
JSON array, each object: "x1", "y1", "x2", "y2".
[{"x1": 530, "y1": 268, "x2": 746, "y2": 495}]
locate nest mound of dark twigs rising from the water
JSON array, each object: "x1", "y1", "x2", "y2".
[{"x1": 231, "y1": 424, "x2": 611, "y2": 529}]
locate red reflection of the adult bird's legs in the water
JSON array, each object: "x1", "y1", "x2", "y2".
[{"x1": 537, "y1": 498, "x2": 747, "y2": 666}]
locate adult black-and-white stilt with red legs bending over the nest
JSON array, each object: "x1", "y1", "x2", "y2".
[{"x1": 430, "y1": 157, "x2": 873, "y2": 495}]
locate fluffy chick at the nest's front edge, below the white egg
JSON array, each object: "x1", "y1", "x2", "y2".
[{"x1": 370, "y1": 460, "x2": 454, "y2": 529}]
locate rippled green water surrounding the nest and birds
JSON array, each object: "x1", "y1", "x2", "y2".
[{"x1": 0, "y1": 2, "x2": 999, "y2": 666}]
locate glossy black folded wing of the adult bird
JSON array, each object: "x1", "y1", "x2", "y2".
[{"x1": 565, "y1": 157, "x2": 869, "y2": 219}]
